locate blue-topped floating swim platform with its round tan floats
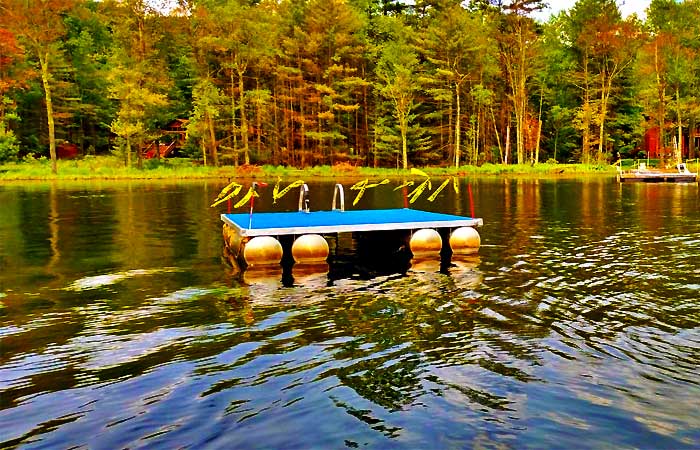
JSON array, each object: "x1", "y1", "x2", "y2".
[{"x1": 221, "y1": 208, "x2": 483, "y2": 266}]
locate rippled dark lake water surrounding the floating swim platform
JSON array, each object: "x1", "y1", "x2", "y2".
[{"x1": 0, "y1": 179, "x2": 700, "y2": 449}]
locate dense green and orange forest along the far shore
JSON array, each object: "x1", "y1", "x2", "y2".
[{"x1": 0, "y1": 0, "x2": 700, "y2": 173}]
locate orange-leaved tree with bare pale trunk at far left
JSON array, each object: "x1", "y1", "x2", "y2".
[{"x1": 0, "y1": 0, "x2": 74, "y2": 174}]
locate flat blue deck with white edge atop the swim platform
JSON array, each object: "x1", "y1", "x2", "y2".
[{"x1": 221, "y1": 209, "x2": 482, "y2": 236}]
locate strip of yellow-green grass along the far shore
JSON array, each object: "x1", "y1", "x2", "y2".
[{"x1": 0, "y1": 156, "x2": 615, "y2": 181}]
